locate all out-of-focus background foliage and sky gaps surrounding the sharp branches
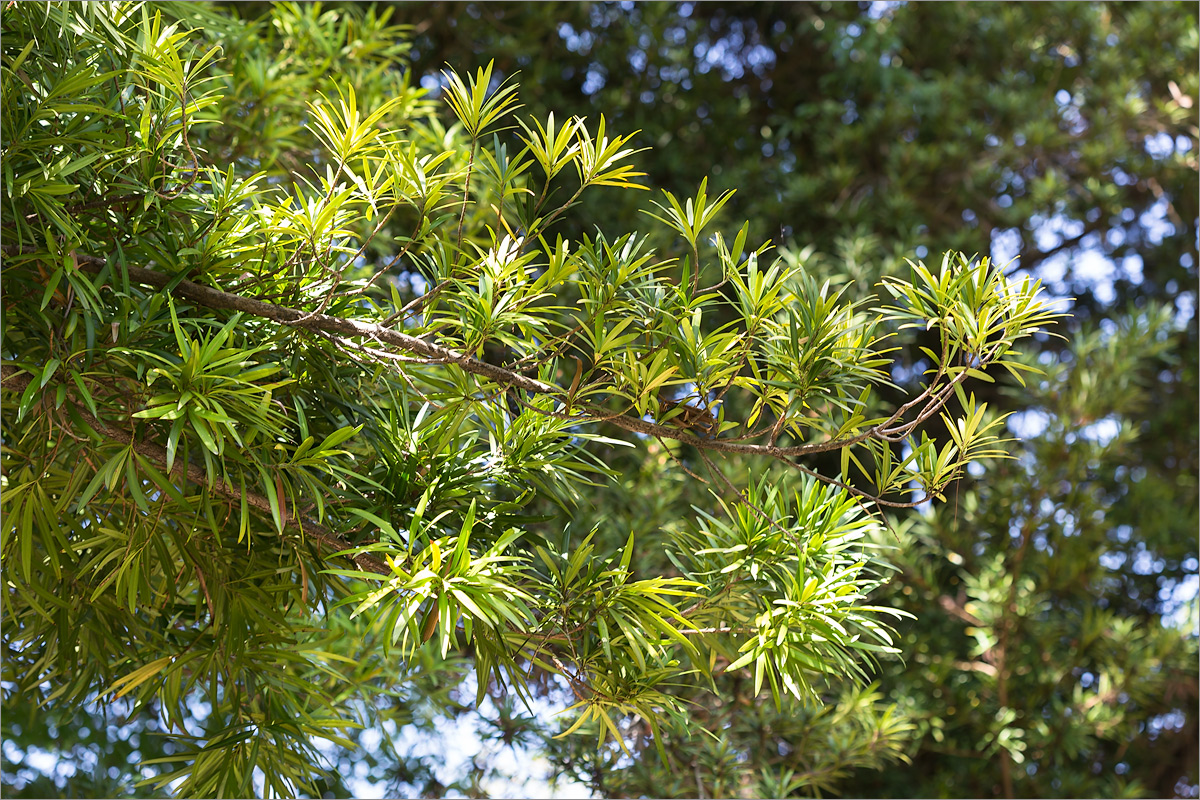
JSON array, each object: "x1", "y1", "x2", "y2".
[{"x1": 2, "y1": 2, "x2": 1200, "y2": 798}]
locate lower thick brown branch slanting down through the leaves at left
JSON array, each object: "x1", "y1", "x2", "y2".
[{"x1": 0, "y1": 365, "x2": 392, "y2": 576}]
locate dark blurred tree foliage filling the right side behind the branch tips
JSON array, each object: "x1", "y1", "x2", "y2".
[{"x1": 386, "y1": 2, "x2": 1200, "y2": 796}]
